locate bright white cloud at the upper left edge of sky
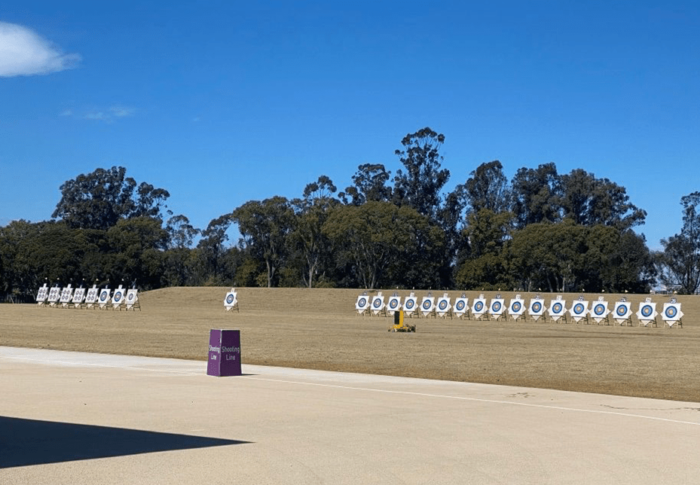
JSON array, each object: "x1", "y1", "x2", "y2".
[{"x1": 0, "y1": 22, "x2": 80, "y2": 77}]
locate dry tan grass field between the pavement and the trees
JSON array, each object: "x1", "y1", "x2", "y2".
[{"x1": 0, "y1": 288, "x2": 700, "y2": 402}]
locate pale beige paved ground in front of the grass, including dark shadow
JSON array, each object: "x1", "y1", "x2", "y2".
[{"x1": 0, "y1": 347, "x2": 700, "y2": 485}]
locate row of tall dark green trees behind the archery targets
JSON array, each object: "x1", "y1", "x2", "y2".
[{"x1": 0, "y1": 128, "x2": 700, "y2": 300}]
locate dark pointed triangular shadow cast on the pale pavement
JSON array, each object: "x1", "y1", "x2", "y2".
[{"x1": 0, "y1": 416, "x2": 250, "y2": 469}]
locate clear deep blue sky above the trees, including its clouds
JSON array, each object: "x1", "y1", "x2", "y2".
[{"x1": 0, "y1": 0, "x2": 700, "y2": 249}]
